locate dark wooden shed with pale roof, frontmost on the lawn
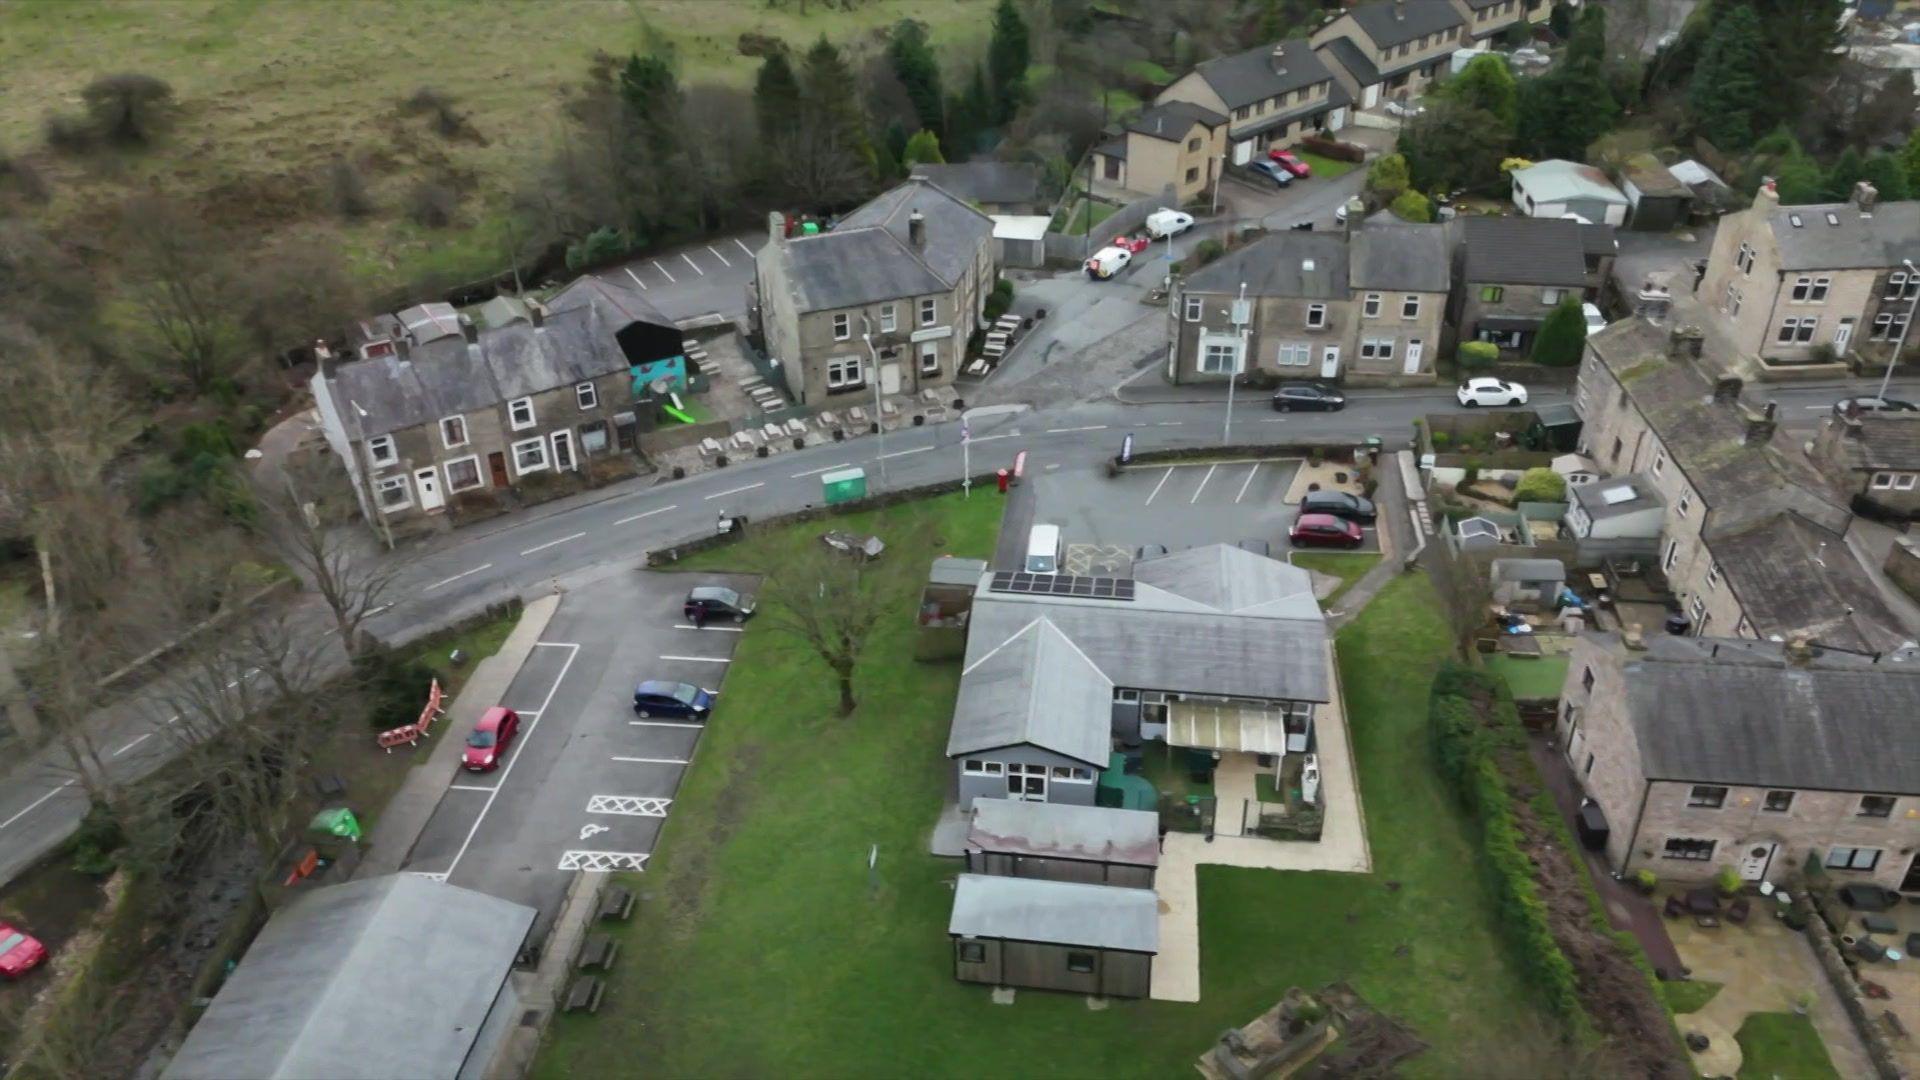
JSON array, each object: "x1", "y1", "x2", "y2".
[{"x1": 947, "y1": 874, "x2": 1160, "y2": 997}]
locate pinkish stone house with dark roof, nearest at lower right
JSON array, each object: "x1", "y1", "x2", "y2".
[{"x1": 1557, "y1": 634, "x2": 1920, "y2": 892}]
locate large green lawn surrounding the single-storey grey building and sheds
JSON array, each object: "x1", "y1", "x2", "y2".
[{"x1": 534, "y1": 534, "x2": 1540, "y2": 1078}]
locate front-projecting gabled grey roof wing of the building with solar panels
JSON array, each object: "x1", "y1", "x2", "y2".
[{"x1": 947, "y1": 614, "x2": 1114, "y2": 767}]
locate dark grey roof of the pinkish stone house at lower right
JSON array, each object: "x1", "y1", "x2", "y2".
[{"x1": 1624, "y1": 638, "x2": 1920, "y2": 796}]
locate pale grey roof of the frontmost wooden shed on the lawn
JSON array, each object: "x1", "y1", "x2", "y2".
[{"x1": 947, "y1": 874, "x2": 1160, "y2": 953}]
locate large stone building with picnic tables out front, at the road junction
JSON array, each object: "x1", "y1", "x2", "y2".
[{"x1": 753, "y1": 179, "x2": 996, "y2": 405}]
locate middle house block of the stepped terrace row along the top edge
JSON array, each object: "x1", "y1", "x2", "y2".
[{"x1": 1308, "y1": 0, "x2": 1469, "y2": 110}]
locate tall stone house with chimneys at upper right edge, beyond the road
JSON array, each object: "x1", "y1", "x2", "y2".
[{"x1": 1693, "y1": 181, "x2": 1920, "y2": 361}]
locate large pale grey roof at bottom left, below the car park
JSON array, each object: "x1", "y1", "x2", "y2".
[{"x1": 163, "y1": 874, "x2": 534, "y2": 1080}]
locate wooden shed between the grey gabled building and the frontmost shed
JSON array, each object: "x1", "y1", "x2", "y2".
[{"x1": 966, "y1": 799, "x2": 1160, "y2": 888}]
